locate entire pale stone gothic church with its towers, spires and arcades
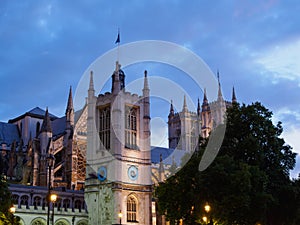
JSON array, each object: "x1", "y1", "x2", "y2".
[{"x1": 0, "y1": 62, "x2": 236, "y2": 225}]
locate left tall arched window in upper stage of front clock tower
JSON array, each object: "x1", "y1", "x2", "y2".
[{"x1": 99, "y1": 107, "x2": 110, "y2": 150}]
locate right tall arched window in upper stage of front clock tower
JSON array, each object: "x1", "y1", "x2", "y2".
[{"x1": 125, "y1": 106, "x2": 138, "y2": 149}]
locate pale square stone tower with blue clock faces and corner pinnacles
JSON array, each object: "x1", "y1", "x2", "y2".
[{"x1": 85, "y1": 62, "x2": 152, "y2": 225}]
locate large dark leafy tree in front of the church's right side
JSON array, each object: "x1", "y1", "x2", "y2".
[{"x1": 156, "y1": 103, "x2": 299, "y2": 225}]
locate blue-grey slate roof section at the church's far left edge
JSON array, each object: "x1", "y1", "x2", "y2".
[{"x1": 0, "y1": 122, "x2": 20, "y2": 145}]
